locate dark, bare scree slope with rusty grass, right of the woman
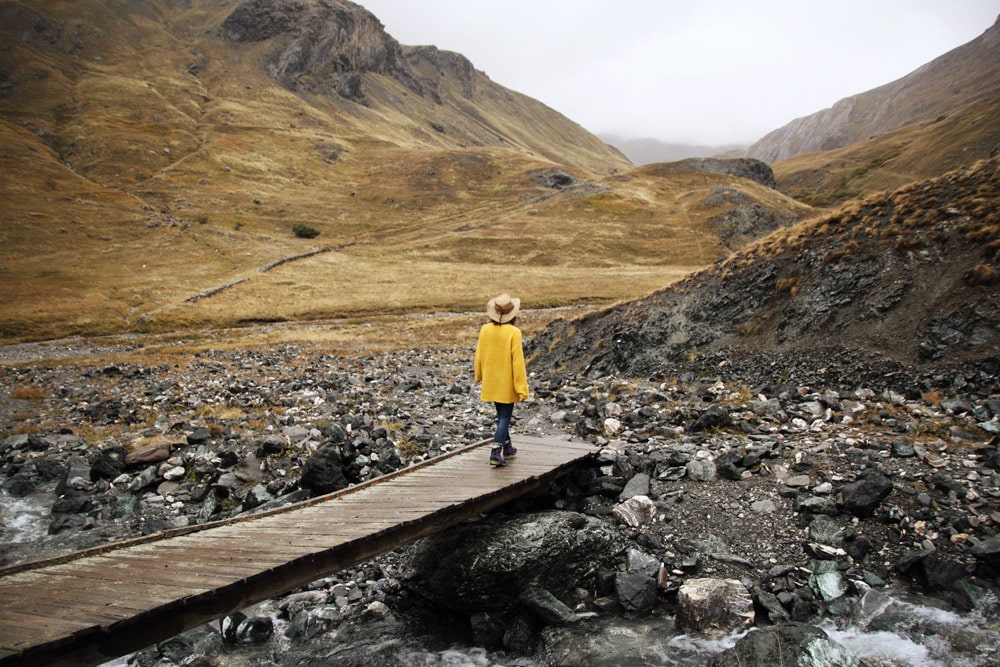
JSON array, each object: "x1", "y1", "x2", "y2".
[{"x1": 530, "y1": 158, "x2": 1000, "y2": 381}]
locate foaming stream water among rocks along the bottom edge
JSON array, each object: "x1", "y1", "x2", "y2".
[{"x1": 94, "y1": 592, "x2": 1000, "y2": 667}]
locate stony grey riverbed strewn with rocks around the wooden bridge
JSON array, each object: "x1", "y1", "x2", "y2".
[{"x1": 0, "y1": 344, "x2": 1000, "y2": 665}]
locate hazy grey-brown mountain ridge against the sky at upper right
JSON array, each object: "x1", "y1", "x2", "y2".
[{"x1": 747, "y1": 17, "x2": 1000, "y2": 163}]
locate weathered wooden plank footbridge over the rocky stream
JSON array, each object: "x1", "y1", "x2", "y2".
[{"x1": 0, "y1": 436, "x2": 595, "y2": 667}]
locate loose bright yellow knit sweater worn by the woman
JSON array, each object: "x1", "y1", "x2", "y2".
[{"x1": 476, "y1": 322, "x2": 528, "y2": 403}]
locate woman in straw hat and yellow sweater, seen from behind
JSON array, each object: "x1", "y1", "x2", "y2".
[{"x1": 475, "y1": 293, "x2": 528, "y2": 466}]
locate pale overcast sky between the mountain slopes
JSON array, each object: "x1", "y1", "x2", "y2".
[{"x1": 356, "y1": 0, "x2": 1000, "y2": 145}]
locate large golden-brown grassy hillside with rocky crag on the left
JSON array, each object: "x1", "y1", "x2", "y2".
[{"x1": 0, "y1": 0, "x2": 809, "y2": 340}]
